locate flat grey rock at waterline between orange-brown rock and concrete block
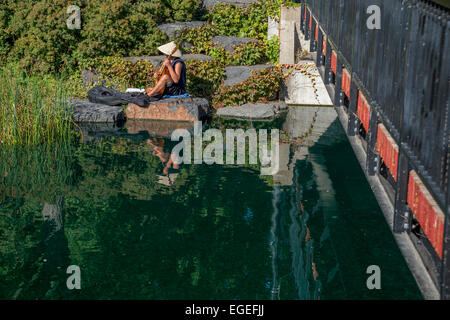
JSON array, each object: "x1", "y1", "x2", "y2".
[{"x1": 216, "y1": 101, "x2": 288, "y2": 120}]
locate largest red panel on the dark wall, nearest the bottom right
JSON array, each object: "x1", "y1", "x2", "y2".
[{"x1": 407, "y1": 170, "x2": 445, "y2": 259}]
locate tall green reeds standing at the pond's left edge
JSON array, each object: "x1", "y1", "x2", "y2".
[{"x1": 0, "y1": 67, "x2": 74, "y2": 146}]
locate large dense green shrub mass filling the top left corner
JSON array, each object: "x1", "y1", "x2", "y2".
[{"x1": 0, "y1": 0, "x2": 201, "y2": 73}]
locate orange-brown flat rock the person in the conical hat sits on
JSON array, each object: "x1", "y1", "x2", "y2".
[{"x1": 126, "y1": 98, "x2": 211, "y2": 121}]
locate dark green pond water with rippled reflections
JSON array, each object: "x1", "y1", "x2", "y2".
[{"x1": 0, "y1": 108, "x2": 421, "y2": 300}]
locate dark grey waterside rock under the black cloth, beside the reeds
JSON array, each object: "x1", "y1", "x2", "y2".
[{"x1": 68, "y1": 99, "x2": 126, "y2": 123}]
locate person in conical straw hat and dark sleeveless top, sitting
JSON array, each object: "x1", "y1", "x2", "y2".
[{"x1": 145, "y1": 41, "x2": 186, "y2": 96}]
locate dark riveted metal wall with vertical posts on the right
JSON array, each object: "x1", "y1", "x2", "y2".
[{"x1": 301, "y1": 0, "x2": 450, "y2": 298}]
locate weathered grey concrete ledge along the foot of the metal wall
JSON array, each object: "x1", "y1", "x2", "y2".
[{"x1": 335, "y1": 107, "x2": 440, "y2": 300}]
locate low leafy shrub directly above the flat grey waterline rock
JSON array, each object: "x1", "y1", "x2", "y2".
[{"x1": 212, "y1": 67, "x2": 283, "y2": 109}]
